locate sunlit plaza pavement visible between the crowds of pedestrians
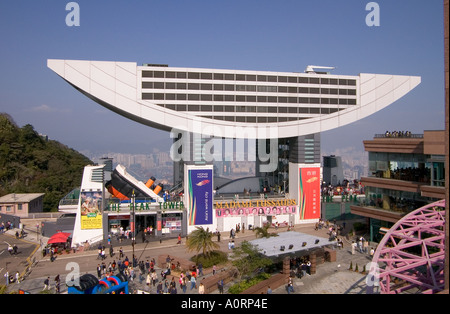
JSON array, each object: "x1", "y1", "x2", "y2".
[{"x1": 1, "y1": 224, "x2": 371, "y2": 294}]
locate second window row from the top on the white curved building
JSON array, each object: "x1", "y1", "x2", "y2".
[{"x1": 142, "y1": 82, "x2": 356, "y2": 95}]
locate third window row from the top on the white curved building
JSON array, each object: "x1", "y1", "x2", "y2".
[{"x1": 142, "y1": 93, "x2": 356, "y2": 105}]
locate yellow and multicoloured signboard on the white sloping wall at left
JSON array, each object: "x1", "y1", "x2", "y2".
[{"x1": 80, "y1": 192, "x2": 103, "y2": 230}]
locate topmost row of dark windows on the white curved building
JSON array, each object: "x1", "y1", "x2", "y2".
[{"x1": 142, "y1": 71, "x2": 356, "y2": 86}]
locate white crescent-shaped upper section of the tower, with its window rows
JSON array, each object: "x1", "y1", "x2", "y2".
[{"x1": 48, "y1": 59, "x2": 421, "y2": 138}]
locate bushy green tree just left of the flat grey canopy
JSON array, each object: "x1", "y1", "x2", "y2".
[{"x1": 232, "y1": 241, "x2": 272, "y2": 277}]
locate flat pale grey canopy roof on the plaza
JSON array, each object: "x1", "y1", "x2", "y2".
[{"x1": 250, "y1": 231, "x2": 337, "y2": 257}]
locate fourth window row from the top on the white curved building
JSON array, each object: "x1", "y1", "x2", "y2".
[{"x1": 158, "y1": 104, "x2": 342, "y2": 114}]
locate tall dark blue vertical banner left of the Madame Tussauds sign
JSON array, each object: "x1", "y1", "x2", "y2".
[{"x1": 188, "y1": 169, "x2": 213, "y2": 226}]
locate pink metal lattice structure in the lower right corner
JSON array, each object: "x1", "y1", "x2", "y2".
[{"x1": 372, "y1": 200, "x2": 445, "y2": 293}]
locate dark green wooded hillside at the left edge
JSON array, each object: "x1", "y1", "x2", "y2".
[{"x1": 0, "y1": 113, "x2": 92, "y2": 211}]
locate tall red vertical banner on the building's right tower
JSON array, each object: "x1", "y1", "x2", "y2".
[{"x1": 299, "y1": 167, "x2": 320, "y2": 219}]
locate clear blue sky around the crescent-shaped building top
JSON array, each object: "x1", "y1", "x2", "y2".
[{"x1": 0, "y1": 0, "x2": 445, "y2": 153}]
